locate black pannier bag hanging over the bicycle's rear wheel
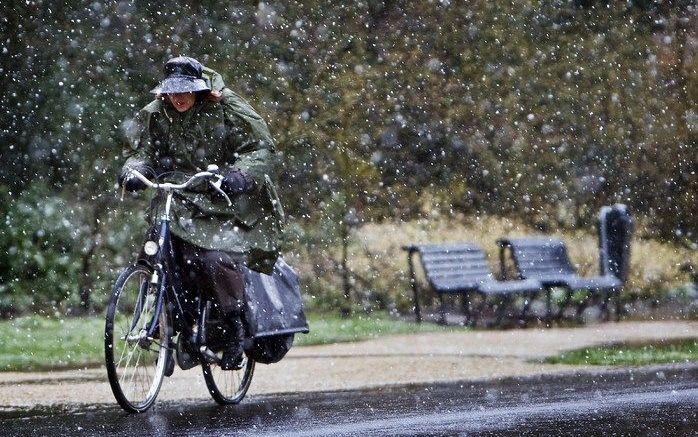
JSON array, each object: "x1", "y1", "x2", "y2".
[{"x1": 242, "y1": 258, "x2": 309, "y2": 364}]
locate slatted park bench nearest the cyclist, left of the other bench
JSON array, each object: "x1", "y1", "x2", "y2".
[{"x1": 403, "y1": 243, "x2": 543, "y2": 325}]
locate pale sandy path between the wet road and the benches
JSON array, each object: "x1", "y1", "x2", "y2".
[{"x1": 0, "y1": 321, "x2": 698, "y2": 411}]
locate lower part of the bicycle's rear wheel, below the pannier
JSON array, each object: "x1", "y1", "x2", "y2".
[{"x1": 201, "y1": 352, "x2": 254, "y2": 405}]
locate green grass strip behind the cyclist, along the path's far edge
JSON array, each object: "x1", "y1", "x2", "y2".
[{"x1": 0, "y1": 313, "x2": 456, "y2": 372}]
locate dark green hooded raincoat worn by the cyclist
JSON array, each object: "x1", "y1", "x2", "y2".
[{"x1": 124, "y1": 68, "x2": 284, "y2": 273}]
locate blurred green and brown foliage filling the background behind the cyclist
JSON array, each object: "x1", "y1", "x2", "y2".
[{"x1": 0, "y1": 0, "x2": 698, "y2": 314}]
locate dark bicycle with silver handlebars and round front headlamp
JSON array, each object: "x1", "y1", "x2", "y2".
[{"x1": 104, "y1": 165, "x2": 255, "y2": 413}]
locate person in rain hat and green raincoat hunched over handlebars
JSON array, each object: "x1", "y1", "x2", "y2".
[{"x1": 119, "y1": 57, "x2": 284, "y2": 370}]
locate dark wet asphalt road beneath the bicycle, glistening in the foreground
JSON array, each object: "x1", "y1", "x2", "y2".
[{"x1": 0, "y1": 365, "x2": 698, "y2": 436}]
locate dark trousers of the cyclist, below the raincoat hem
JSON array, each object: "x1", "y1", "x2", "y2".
[{"x1": 172, "y1": 235, "x2": 245, "y2": 314}]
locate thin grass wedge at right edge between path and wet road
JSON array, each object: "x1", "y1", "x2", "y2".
[{"x1": 545, "y1": 339, "x2": 698, "y2": 366}]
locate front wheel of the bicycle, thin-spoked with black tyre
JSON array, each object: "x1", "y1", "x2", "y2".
[{"x1": 104, "y1": 265, "x2": 171, "y2": 413}]
